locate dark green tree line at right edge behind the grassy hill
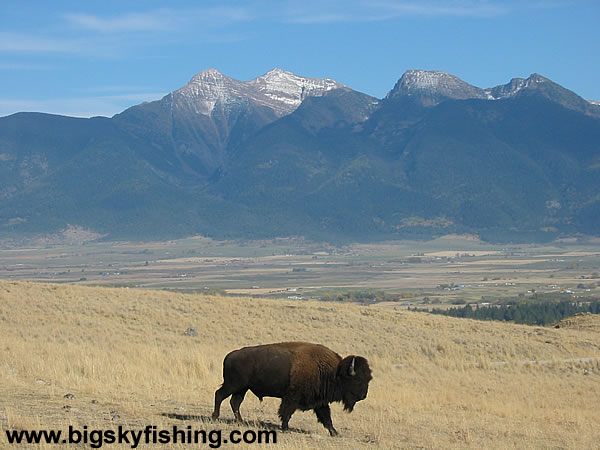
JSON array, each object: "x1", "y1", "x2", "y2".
[{"x1": 418, "y1": 299, "x2": 600, "y2": 325}]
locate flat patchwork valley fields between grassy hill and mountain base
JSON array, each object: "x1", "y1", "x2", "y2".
[{"x1": 0, "y1": 236, "x2": 600, "y2": 304}]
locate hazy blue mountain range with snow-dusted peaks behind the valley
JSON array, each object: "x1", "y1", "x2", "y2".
[{"x1": 0, "y1": 69, "x2": 600, "y2": 241}]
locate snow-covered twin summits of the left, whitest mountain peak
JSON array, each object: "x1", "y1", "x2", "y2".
[{"x1": 173, "y1": 69, "x2": 345, "y2": 116}]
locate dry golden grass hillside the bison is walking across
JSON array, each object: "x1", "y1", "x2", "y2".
[{"x1": 0, "y1": 281, "x2": 600, "y2": 449}]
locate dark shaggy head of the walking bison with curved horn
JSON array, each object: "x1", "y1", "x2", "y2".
[{"x1": 337, "y1": 355, "x2": 373, "y2": 412}]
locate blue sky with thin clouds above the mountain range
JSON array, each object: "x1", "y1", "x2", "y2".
[{"x1": 0, "y1": 0, "x2": 600, "y2": 117}]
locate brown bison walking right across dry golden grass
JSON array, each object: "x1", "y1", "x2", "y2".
[{"x1": 212, "y1": 342, "x2": 372, "y2": 436}]
